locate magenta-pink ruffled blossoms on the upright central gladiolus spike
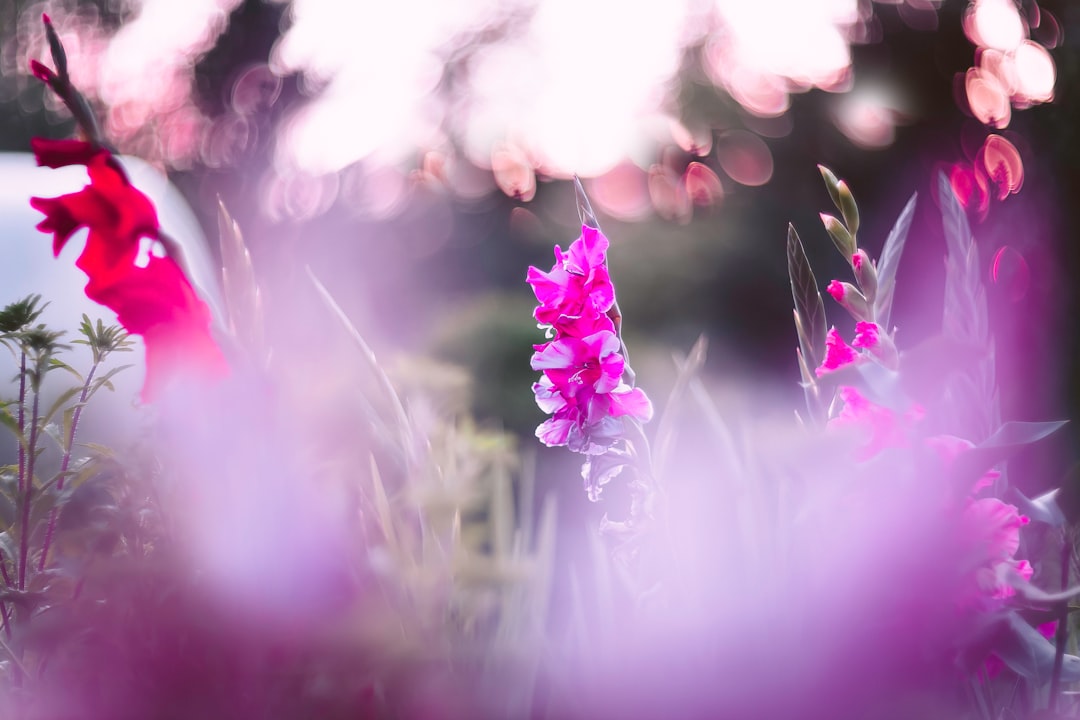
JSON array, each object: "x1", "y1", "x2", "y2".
[{"x1": 527, "y1": 226, "x2": 652, "y2": 456}]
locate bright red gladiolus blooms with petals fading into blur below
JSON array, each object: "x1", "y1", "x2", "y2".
[{"x1": 30, "y1": 138, "x2": 228, "y2": 402}]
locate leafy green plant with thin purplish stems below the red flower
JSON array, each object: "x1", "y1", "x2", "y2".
[{"x1": 0, "y1": 296, "x2": 131, "y2": 684}]
